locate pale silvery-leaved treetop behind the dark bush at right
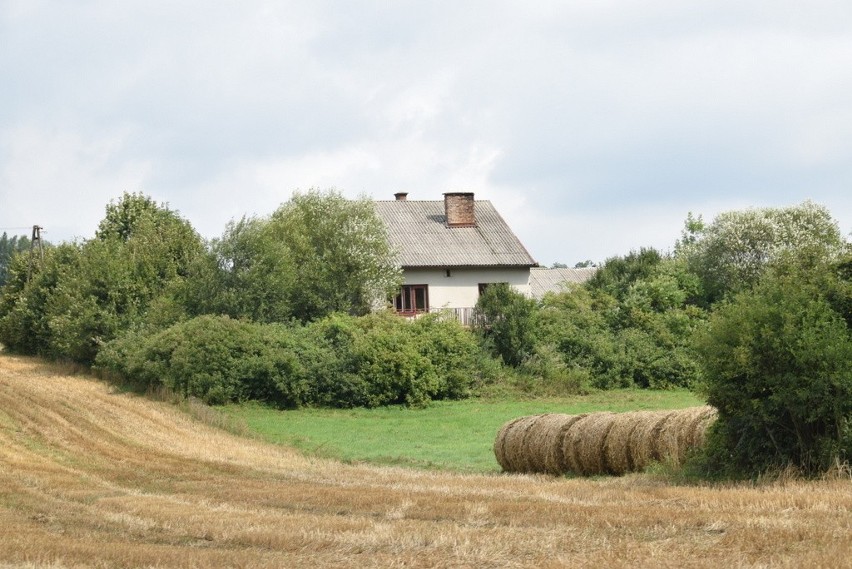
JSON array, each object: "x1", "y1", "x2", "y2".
[{"x1": 676, "y1": 201, "x2": 843, "y2": 305}]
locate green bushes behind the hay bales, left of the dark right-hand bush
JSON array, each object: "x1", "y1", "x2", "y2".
[{"x1": 526, "y1": 274, "x2": 705, "y2": 389}]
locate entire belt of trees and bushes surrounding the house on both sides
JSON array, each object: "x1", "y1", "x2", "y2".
[{"x1": 0, "y1": 190, "x2": 852, "y2": 478}]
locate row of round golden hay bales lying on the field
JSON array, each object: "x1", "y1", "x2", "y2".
[{"x1": 494, "y1": 407, "x2": 716, "y2": 475}]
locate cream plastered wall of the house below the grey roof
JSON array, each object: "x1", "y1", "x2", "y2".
[{"x1": 403, "y1": 268, "x2": 531, "y2": 310}]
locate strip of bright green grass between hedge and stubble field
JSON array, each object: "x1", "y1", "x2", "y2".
[{"x1": 221, "y1": 390, "x2": 703, "y2": 472}]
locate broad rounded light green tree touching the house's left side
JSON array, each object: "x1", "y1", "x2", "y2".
[{"x1": 208, "y1": 190, "x2": 402, "y2": 322}]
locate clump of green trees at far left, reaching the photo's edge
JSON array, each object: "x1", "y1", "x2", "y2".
[{"x1": 0, "y1": 193, "x2": 204, "y2": 364}]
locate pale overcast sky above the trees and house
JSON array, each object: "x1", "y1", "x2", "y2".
[{"x1": 0, "y1": 0, "x2": 852, "y2": 265}]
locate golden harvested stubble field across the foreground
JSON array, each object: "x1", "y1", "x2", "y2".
[{"x1": 0, "y1": 354, "x2": 852, "y2": 568}]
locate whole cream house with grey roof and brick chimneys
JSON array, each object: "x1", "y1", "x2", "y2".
[{"x1": 376, "y1": 192, "x2": 538, "y2": 324}]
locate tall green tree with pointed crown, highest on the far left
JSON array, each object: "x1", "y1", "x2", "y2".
[{"x1": 49, "y1": 193, "x2": 204, "y2": 363}]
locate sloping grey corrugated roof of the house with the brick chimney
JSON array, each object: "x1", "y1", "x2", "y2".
[{"x1": 376, "y1": 200, "x2": 537, "y2": 267}]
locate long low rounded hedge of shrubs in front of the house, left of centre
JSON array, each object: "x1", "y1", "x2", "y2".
[{"x1": 97, "y1": 313, "x2": 480, "y2": 407}]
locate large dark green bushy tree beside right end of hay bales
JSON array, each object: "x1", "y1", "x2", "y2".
[{"x1": 698, "y1": 254, "x2": 852, "y2": 474}]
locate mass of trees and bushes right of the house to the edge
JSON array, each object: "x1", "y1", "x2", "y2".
[{"x1": 479, "y1": 202, "x2": 852, "y2": 475}]
